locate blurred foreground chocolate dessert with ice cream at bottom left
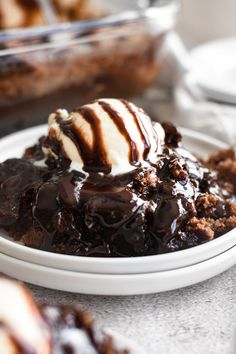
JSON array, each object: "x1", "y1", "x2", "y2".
[{"x1": 0, "y1": 278, "x2": 128, "y2": 354}]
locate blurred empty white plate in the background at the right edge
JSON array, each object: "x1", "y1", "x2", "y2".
[{"x1": 191, "y1": 37, "x2": 236, "y2": 104}]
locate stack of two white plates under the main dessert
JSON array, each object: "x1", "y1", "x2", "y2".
[{"x1": 0, "y1": 126, "x2": 236, "y2": 295}]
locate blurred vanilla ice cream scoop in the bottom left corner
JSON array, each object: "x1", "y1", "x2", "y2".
[{"x1": 0, "y1": 278, "x2": 51, "y2": 354}]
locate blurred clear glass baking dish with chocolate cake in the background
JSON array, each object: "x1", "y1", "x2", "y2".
[{"x1": 0, "y1": 0, "x2": 179, "y2": 136}]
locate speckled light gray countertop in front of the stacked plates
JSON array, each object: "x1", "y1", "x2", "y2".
[{"x1": 29, "y1": 267, "x2": 236, "y2": 354}]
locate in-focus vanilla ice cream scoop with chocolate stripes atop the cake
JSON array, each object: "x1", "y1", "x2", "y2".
[{"x1": 46, "y1": 99, "x2": 165, "y2": 175}]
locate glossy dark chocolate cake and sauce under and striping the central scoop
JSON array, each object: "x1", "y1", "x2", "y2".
[{"x1": 0, "y1": 123, "x2": 235, "y2": 257}]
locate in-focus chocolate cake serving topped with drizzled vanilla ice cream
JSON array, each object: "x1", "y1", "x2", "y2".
[{"x1": 0, "y1": 99, "x2": 236, "y2": 257}]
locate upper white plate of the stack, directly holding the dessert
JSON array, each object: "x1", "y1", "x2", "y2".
[{"x1": 0, "y1": 125, "x2": 236, "y2": 274}]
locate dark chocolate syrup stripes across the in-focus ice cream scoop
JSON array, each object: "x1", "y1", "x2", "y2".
[{"x1": 56, "y1": 99, "x2": 156, "y2": 174}]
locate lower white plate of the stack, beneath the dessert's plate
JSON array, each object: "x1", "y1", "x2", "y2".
[{"x1": 0, "y1": 246, "x2": 236, "y2": 295}]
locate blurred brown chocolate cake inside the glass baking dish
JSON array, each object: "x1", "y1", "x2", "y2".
[{"x1": 0, "y1": 31, "x2": 163, "y2": 106}]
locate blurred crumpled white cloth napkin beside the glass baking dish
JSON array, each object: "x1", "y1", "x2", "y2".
[{"x1": 149, "y1": 33, "x2": 236, "y2": 145}]
